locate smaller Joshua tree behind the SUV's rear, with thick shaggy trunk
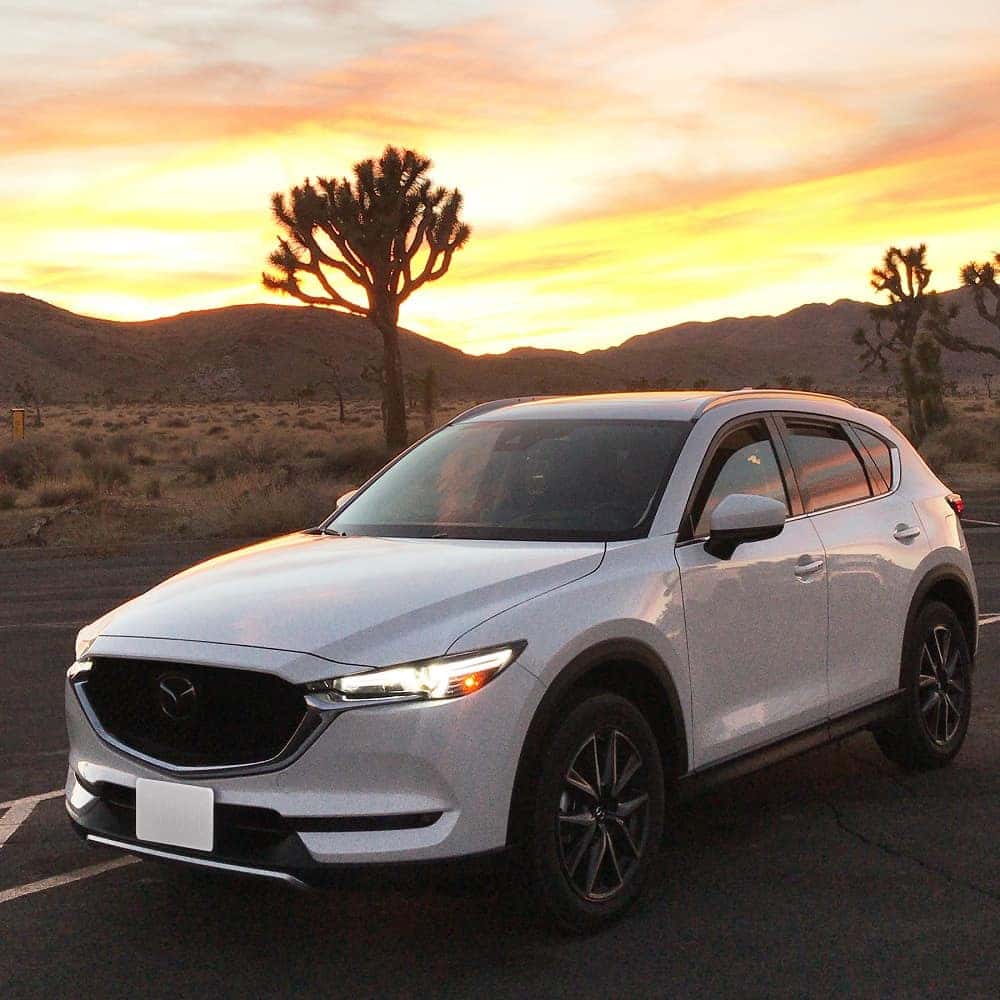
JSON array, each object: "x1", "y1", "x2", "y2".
[{"x1": 854, "y1": 243, "x2": 1000, "y2": 444}]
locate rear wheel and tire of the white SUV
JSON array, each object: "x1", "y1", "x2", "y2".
[{"x1": 874, "y1": 601, "x2": 972, "y2": 771}]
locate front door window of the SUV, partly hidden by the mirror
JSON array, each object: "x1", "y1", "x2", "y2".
[{"x1": 689, "y1": 421, "x2": 788, "y2": 538}]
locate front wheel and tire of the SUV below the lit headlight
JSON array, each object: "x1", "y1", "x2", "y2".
[{"x1": 522, "y1": 692, "x2": 664, "y2": 933}]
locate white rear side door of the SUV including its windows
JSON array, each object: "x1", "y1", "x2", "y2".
[{"x1": 779, "y1": 414, "x2": 928, "y2": 716}]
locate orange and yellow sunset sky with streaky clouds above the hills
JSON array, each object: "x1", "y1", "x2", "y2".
[{"x1": 0, "y1": 0, "x2": 1000, "y2": 352}]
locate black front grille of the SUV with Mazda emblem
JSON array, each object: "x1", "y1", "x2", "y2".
[{"x1": 81, "y1": 657, "x2": 307, "y2": 767}]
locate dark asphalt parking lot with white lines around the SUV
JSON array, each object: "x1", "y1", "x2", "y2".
[{"x1": 0, "y1": 528, "x2": 1000, "y2": 998}]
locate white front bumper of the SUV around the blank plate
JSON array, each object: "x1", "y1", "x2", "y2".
[{"x1": 66, "y1": 663, "x2": 542, "y2": 881}]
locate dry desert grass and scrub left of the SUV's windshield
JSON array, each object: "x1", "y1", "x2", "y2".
[{"x1": 0, "y1": 402, "x2": 469, "y2": 549}]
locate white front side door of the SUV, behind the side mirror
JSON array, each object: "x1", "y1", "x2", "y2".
[{"x1": 676, "y1": 417, "x2": 829, "y2": 767}]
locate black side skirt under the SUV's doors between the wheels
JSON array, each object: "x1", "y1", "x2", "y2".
[{"x1": 677, "y1": 690, "x2": 906, "y2": 799}]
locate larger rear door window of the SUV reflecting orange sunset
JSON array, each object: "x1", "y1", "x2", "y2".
[{"x1": 785, "y1": 419, "x2": 871, "y2": 512}]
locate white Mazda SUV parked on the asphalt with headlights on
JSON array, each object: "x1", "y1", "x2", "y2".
[{"x1": 66, "y1": 390, "x2": 977, "y2": 929}]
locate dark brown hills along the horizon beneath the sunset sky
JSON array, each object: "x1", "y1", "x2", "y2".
[{"x1": 0, "y1": 289, "x2": 1000, "y2": 402}]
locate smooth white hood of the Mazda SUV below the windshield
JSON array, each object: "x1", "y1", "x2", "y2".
[{"x1": 101, "y1": 534, "x2": 605, "y2": 666}]
